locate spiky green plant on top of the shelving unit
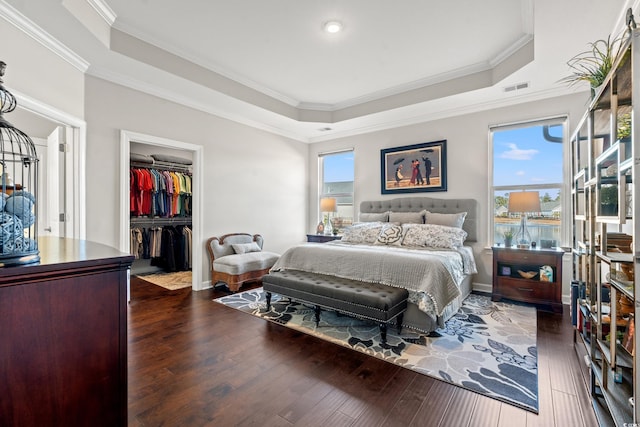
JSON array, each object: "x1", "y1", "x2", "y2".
[{"x1": 560, "y1": 35, "x2": 624, "y2": 94}]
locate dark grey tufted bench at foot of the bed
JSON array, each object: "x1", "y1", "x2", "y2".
[{"x1": 262, "y1": 270, "x2": 409, "y2": 344}]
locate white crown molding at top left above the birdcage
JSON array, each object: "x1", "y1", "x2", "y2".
[{"x1": 0, "y1": 0, "x2": 89, "y2": 73}]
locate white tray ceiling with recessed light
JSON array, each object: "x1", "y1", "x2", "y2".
[{"x1": 0, "y1": 0, "x2": 632, "y2": 142}]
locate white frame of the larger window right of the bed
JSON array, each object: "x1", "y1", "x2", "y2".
[{"x1": 487, "y1": 115, "x2": 572, "y2": 247}]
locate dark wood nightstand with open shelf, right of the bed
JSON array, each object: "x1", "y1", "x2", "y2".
[{"x1": 491, "y1": 246, "x2": 564, "y2": 314}]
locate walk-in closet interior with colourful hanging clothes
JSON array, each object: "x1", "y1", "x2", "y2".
[{"x1": 129, "y1": 142, "x2": 193, "y2": 289}]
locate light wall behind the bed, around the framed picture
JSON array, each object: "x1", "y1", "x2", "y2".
[{"x1": 308, "y1": 94, "x2": 586, "y2": 294}]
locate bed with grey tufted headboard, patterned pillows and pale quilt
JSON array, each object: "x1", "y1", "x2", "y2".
[{"x1": 271, "y1": 197, "x2": 477, "y2": 333}]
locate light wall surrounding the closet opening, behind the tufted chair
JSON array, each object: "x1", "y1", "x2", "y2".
[{"x1": 85, "y1": 77, "x2": 308, "y2": 281}]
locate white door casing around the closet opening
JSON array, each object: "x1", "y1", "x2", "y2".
[{"x1": 120, "y1": 130, "x2": 203, "y2": 299}]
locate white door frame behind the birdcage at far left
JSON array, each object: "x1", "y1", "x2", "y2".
[{"x1": 12, "y1": 90, "x2": 87, "y2": 239}]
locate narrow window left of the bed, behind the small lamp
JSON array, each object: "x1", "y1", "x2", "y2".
[{"x1": 318, "y1": 150, "x2": 354, "y2": 232}]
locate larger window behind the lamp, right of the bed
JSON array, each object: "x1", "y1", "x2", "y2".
[{"x1": 490, "y1": 118, "x2": 570, "y2": 246}]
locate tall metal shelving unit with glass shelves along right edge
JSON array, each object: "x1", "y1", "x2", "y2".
[{"x1": 571, "y1": 31, "x2": 640, "y2": 426}]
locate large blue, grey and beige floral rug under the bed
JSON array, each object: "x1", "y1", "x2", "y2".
[{"x1": 214, "y1": 288, "x2": 538, "y2": 413}]
